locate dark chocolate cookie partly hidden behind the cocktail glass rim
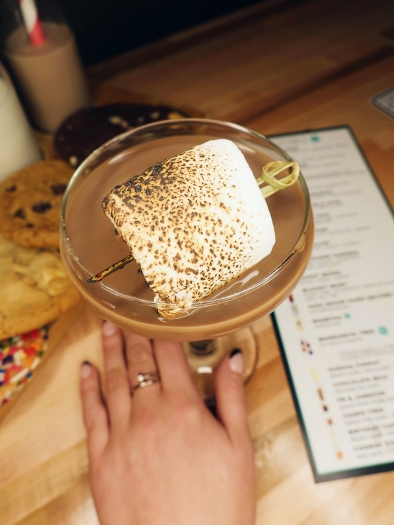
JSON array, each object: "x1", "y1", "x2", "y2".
[{"x1": 54, "y1": 104, "x2": 189, "y2": 168}]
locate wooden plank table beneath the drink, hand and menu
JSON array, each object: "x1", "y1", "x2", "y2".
[{"x1": 0, "y1": 0, "x2": 394, "y2": 525}]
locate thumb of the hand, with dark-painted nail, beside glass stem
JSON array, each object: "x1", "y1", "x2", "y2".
[{"x1": 215, "y1": 348, "x2": 249, "y2": 442}]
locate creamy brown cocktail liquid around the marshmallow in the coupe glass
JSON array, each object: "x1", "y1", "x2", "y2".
[{"x1": 62, "y1": 136, "x2": 313, "y2": 341}]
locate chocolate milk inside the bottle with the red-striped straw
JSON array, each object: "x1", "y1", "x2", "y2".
[{"x1": 5, "y1": 22, "x2": 89, "y2": 132}]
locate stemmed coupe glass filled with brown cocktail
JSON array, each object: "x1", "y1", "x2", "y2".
[{"x1": 60, "y1": 119, "x2": 313, "y2": 403}]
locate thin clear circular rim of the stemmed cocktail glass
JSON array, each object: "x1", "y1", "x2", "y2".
[{"x1": 60, "y1": 118, "x2": 311, "y2": 310}]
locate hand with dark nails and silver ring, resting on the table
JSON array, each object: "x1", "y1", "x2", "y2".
[{"x1": 81, "y1": 322, "x2": 255, "y2": 525}]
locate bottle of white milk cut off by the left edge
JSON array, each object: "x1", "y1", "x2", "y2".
[{"x1": 0, "y1": 63, "x2": 41, "y2": 181}]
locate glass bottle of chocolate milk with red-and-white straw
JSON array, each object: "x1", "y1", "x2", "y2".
[{"x1": 0, "y1": 0, "x2": 89, "y2": 133}]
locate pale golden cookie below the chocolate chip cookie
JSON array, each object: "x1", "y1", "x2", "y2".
[{"x1": 0, "y1": 231, "x2": 79, "y2": 339}]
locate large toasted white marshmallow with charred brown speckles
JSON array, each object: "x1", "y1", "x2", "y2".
[{"x1": 103, "y1": 139, "x2": 275, "y2": 317}]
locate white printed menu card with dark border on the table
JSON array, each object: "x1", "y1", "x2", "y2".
[{"x1": 270, "y1": 127, "x2": 394, "y2": 482}]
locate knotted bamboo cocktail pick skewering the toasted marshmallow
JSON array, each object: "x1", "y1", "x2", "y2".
[{"x1": 86, "y1": 161, "x2": 300, "y2": 283}]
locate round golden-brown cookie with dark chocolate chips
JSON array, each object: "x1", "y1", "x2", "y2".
[{"x1": 0, "y1": 160, "x2": 73, "y2": 248}]
